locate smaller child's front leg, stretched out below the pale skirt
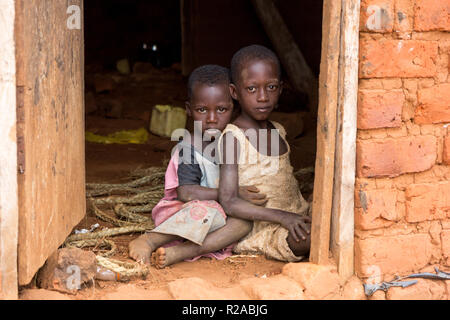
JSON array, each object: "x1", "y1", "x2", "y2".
[{"x1": 152, "y1": 217, "x2": 253, "y2": 268}]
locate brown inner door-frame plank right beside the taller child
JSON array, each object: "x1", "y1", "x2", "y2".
[{"x1": 309, "y1": 0, "x2": 341, "y2": 264}]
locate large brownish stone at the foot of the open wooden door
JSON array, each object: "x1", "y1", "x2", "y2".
[{"x1": 36, "y1": 248, "x2": 97, "y2": 293}]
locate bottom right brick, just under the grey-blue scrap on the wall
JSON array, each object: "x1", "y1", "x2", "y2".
[{"x1": 386, "y1": 278, "x2": 446, "y2": 300}]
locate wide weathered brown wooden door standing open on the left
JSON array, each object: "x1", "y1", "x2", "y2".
[{"x1": 15, "y1": 0, "x2": 86, "y2": 285}]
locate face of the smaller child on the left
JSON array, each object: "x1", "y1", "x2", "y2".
[{"x1": 186, "y1": 83, "x2": 233, "y2": 135}]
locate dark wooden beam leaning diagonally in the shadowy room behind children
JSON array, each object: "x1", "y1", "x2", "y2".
[{"x1": 252, "y1": 0, "x2": 317, "y2": 115}]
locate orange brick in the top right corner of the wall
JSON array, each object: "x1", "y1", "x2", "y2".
[{"x1": 414, "y1": 0, "x2": 450, "y2": 31}]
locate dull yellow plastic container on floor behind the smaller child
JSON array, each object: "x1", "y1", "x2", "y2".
[{"x1": 150, "y1": 105, "x2": 187, "y2": 138}]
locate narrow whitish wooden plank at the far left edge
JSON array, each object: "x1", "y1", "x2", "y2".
[{"x1": 0, "y1": 0, "x2": 19, "y2": 300}]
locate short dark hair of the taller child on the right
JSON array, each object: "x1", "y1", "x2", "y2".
[{"x1": 231, "y1": 44, "x2": 281, "y2": 83}]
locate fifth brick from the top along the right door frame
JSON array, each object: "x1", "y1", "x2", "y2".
[{"x1": 355, "y1": 189, "x2": 400, "y2": 230}]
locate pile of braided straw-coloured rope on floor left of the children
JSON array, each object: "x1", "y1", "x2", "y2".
[{"x1": 64, "y1": 167, "x2": 166, "y2": 279}]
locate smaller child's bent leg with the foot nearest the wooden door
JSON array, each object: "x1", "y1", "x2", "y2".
[{"x1": 128, "y1": 232, "x2": 181, "y2": 263}]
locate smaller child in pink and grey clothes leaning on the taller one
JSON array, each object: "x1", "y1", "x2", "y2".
[{"x1": 129, "y1": 65, "x2": 265, "y2": 268}]
